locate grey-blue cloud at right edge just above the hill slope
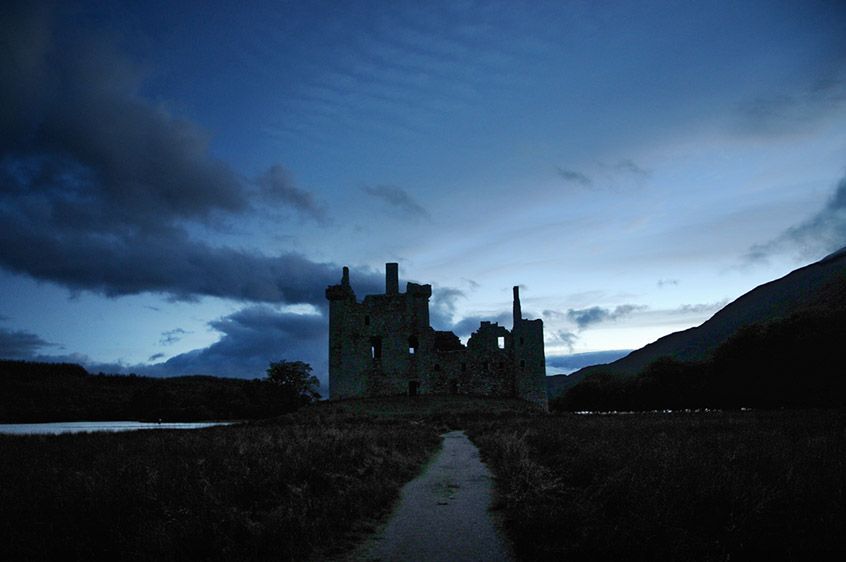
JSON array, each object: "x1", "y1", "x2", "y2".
[{"x1": 746, "y1": 173, "x2": 846, "y2": 261}]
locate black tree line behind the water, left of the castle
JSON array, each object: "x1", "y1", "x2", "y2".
[{"x1": 0, "y1": 360, "x2": 320, "y2": 423}]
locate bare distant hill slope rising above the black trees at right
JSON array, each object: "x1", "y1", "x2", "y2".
[{"x1": 567, "y1": 248, "x2": 846, "y2": 380}]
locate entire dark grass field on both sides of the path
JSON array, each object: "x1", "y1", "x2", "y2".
[{"x1": 0, "y1": 397, "x2": 846, "y2": 560}]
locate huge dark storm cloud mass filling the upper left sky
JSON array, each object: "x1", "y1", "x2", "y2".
[{"x1": 0, "y1": 3, "x2": 352, "y2": 303}]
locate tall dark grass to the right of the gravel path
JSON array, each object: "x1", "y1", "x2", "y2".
[{"x1": 470, "y1": 411, "x2": 846, "y2": 560}]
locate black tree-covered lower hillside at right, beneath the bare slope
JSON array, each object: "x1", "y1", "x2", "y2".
[{"x1": 550, "y1": 309, "x2": 846, "y2": 411}]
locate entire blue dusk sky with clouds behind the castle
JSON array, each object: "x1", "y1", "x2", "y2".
[{"x1": 0, "y1": 1, "x2": 846, "y2": 390}]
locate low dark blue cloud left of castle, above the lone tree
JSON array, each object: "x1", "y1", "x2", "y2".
[{"x1": 144, "y1": 305, "x2": 328, "y2": 382}]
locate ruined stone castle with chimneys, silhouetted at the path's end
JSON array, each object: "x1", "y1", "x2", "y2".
[{"x1": 326, "y1": 263, "x2": 547, "y2": 409}]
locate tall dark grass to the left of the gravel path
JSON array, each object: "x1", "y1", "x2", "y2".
[{"x1": 0, "y1": 412, "x2": 439, "y2": 560}]
